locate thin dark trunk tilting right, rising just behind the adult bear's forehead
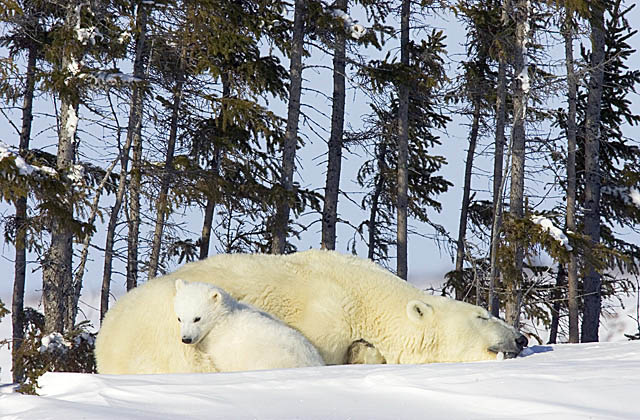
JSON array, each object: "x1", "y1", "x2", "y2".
[{"x1": 456, "y1": 97, "x2": 481, "y2": 300}]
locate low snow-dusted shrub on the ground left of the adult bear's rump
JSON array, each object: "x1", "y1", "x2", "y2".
[{"x1": 17, "y1": 308, "x2": 96, "y2": 394}]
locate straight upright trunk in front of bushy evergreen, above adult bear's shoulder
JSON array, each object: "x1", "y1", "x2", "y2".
[{"x1": 396, "y1": 0, "x2": 411, "y2": 280}]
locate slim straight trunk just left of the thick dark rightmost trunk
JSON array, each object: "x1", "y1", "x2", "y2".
[{"x1": 563, "y1": 9, "x2": 579, "y2": 343}]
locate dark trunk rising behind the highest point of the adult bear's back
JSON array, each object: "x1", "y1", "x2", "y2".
[{"x1": 322, "y1": 0, "x2": 347, "y2": 249}]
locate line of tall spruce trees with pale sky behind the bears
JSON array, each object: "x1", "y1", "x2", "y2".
[{"x1": 0, "y1": 0, "x2": 640, "y2": 381}]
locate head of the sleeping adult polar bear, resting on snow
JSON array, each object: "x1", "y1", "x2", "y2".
[{"x1": 397, "y1": 296, "x2": 528, "y2": 363}]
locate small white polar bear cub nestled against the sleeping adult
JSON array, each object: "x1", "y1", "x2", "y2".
[{"x1": 173, "y1": 279, "x2": 325, "y2": 372}]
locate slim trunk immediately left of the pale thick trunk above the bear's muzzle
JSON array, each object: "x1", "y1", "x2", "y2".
[{"x1": 488, "y1": 47, "x2": 507, "y2": 316}]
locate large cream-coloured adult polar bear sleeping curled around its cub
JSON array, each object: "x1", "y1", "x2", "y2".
[{"x1": 96, "y1": 250, "x2": 527, "y2": 373}]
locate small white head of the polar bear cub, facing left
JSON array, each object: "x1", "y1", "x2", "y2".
[{"x1": 173, "y1": 279, "x2": 226, "y2": 345}]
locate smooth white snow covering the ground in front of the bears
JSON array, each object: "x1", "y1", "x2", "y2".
[{"x1": 0, "y1": 341, "x2": 640, "y2": 420}]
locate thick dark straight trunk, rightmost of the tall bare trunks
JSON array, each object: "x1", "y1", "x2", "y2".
[{"x1": 582, "y1": 2, "x2": 605, "y2": 342}]
